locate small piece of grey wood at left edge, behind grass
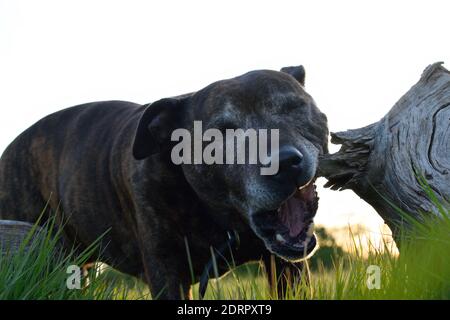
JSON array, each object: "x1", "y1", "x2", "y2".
[{"x1": 0, "y1": 220, "x2": 42, "y2": 256}]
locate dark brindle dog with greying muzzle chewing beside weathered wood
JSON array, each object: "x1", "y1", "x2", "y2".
[{"x1": 0, "y1": 66, "x2": 328, "y2": 299}]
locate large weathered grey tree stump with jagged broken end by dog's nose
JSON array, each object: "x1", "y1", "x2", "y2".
[{"x1": 319, "y1": 63, "x2": 450, "y2": 237}]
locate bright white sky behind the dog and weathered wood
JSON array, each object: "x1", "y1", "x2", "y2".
[{"x1": 0, "y1": 0, "x2": 450, "y2": 235}]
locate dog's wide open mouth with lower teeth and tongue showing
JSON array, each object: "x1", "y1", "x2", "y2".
[{"x1": 252, "y1": 181, "x2": 318, "y2": 261}]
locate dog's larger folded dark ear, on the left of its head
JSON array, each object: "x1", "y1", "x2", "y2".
[{"x1": 133, "y1": 98, "x2": 188, "y2": 160}]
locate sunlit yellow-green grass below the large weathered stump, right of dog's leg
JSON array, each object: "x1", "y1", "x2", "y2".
[{"x1": 194, "y1": 177, "x2": 450, "y2": 300}]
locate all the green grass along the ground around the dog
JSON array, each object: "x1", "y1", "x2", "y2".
[{"x1": 0, "y1": 180, "x2": 450, "y2": 300}]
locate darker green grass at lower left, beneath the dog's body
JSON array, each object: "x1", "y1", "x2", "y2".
[{"x1": 0, "y1": 219, "x2": 135, "y2": 300}]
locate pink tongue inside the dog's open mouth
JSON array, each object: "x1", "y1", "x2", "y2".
[{"x1": 279, "y1": 184, "x2": 314, "y2": 238}]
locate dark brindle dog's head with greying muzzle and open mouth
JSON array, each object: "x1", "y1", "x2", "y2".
[{"x1": 133, "y1": 66, "x2": 328, "y2": 260}]
